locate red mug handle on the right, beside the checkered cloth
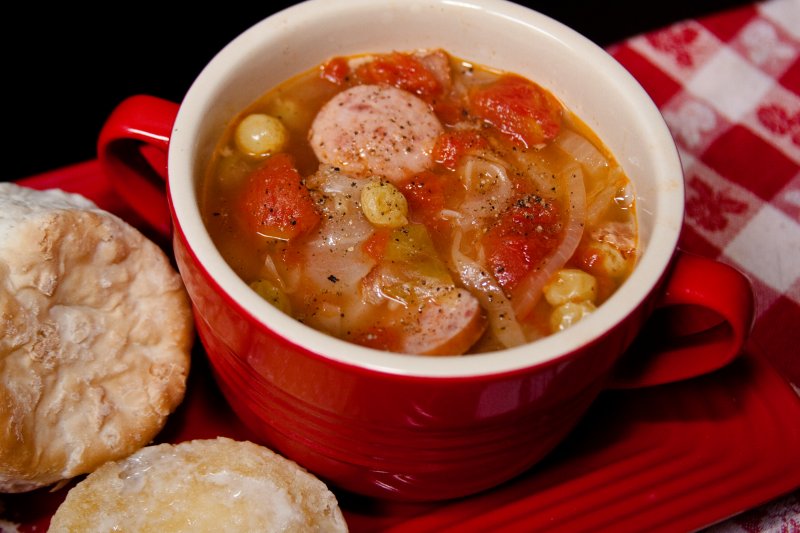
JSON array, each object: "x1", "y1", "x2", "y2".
[{"x1": 608, "y1": 249, "x2": 754, "y2": 389}]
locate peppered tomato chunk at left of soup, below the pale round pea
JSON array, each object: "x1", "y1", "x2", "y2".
[{"x1": 239, "y1": 153, "x2": 320, "y2": 239}]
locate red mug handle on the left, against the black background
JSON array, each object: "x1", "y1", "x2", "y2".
[{"x1": 97, "y1": 95, "x2": 179, "y2": 237}]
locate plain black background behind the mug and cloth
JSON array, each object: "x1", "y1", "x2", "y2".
[{"x1": 0, "y1": 0, "x2": 751, "y2": 180}]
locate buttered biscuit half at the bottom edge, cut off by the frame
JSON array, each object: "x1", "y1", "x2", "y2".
[{"x1": 48, "y1": 437, "x2": 348, "y2": 533}]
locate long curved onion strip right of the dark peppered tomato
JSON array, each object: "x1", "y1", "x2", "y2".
[{"x1": 511, "y1": 166, "x2": 586, "y2": 318}]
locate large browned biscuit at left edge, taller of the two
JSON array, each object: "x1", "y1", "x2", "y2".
[{"x1": 0, "y1": 183, "x2": 194, "y2": 492}]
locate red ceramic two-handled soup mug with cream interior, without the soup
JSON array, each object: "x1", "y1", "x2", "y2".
[{"x1": 99, "y1": 0, "x2": 753, "y2": 500}]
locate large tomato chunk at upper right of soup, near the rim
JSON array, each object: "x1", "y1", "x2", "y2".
[{"x1": 469, "y1": 74, "x2": 562, "y2": 148}]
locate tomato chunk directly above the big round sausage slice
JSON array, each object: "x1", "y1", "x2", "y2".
[{"x1": 355, "y1": 52, "x2": 444, "y2": 101}]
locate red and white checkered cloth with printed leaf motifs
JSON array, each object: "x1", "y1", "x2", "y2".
[{"x1": 608, "y1": 0, "x2": 800, "y2": 533}]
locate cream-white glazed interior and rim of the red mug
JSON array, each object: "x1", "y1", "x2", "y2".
[{"x1": 169, "y1": 0, "x2": 684, "y2": 377}]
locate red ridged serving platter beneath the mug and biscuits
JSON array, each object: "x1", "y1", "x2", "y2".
[{"x1": 0, "y1": 161, "x2": 800, "y2": 533}]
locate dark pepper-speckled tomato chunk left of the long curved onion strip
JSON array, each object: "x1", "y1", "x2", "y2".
[{"x1": 482, "y1": 196, "x2": 563, "y2": 292}]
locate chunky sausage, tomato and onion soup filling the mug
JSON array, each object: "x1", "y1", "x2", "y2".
[{"x1": 201, "y1": 50, "x2": 637, "y2": 355}]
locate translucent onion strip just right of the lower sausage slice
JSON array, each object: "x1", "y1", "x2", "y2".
[{"x1": 451, "y1": 231, "x2": 526, "y2": 348}]
